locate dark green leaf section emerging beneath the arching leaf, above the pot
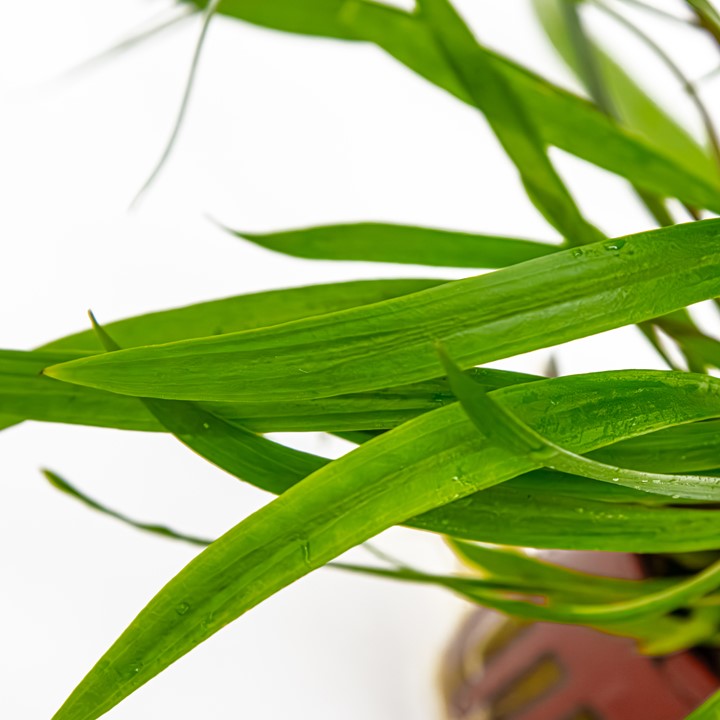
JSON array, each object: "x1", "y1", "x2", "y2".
[{"x1": 416, "y1": 471, "x2": 720, "y2": 553}]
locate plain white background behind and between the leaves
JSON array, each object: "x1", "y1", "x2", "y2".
[{"x1": 0, "y1": 0, "x2": 720, "y2": 720}]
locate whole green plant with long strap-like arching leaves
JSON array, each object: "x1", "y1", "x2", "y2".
[{"x1": 11, "y1": 0, "x2": 720, "y2": 720}]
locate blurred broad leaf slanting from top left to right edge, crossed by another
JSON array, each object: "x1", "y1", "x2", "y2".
[{"x1": 181, "y1": 0, "x2": 720, "y2": 212}]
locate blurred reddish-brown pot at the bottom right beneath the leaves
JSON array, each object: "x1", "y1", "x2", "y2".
[{"x1": 442, "y1": 552, "x2": 720, "y2": 720}]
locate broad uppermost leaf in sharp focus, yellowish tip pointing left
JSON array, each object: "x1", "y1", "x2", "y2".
[{"x1": 45, "y1": 220, "x2": 720, "y2": 402}]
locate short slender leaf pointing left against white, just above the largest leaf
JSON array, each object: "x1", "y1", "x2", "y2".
[{"x1": 233, "y1": 223, "x2": 559, "y2": 268}]
